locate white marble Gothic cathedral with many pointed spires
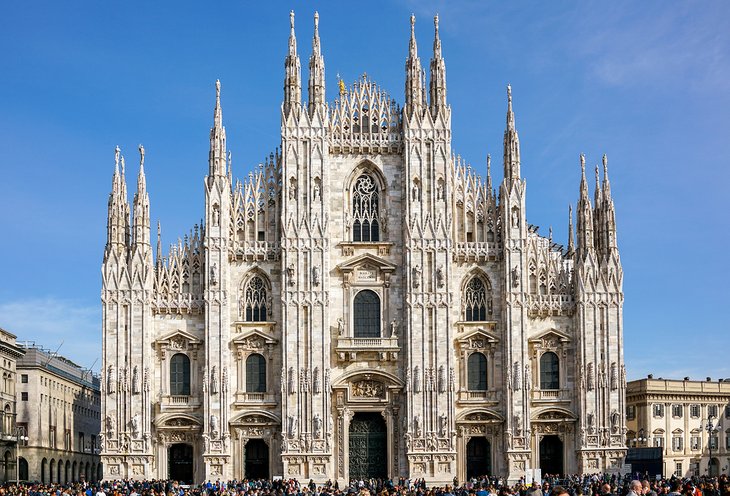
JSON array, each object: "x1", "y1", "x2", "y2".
[{"x1": 101, "y1": 13, "x2": 626, "y2": 484}]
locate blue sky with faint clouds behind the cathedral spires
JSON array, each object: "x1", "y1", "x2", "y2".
[{"x1": 0, "y1": 1, "x2": 730, "y2": 379}]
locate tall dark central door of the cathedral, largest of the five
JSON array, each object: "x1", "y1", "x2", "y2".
[{"x1": 349, "y1": 412, "x2": 388, "y2": 480}]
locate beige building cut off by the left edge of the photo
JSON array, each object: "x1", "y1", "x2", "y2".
[{"x1": 0, "y1": 328, "x2": 23, "y2": 483}]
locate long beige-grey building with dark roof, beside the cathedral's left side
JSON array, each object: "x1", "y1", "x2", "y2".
[{"x1": 17, "y1": 344, "x2": 102, "y2": 483}]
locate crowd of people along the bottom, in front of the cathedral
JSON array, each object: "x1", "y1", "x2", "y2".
[{"x1": 0, "y1": 474, "x2": 730, "y2": 496}]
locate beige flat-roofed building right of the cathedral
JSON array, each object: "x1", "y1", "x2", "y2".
[{"x1": 626, "y1": 375, "x2": 730, "y2": 477}]
